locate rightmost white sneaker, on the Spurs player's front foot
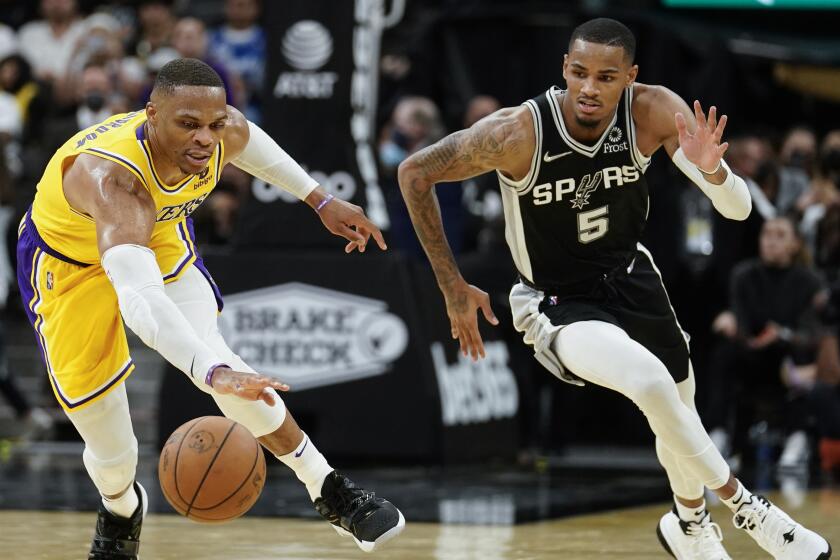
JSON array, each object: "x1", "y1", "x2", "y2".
[{"x1": 732, "y1": 494, "x2": 831, "y2": 560}]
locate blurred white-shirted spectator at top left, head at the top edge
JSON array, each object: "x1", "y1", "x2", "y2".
[{"x1": 18, "y1": 0, "x2": 85, "y2": 94}]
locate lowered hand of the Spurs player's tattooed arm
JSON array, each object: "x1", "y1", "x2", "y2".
[{"x1": 443, "y1": 280, "x2": 499, "y2": 361}]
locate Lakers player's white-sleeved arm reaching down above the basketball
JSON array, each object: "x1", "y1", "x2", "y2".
[{"x1": 64, "y1": 154, "x2": 288, "y2": 404}]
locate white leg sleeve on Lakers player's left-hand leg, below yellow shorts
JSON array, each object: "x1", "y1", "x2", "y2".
[{"x1": 67, "y1": 383, "x2": 137, "y2": 496}]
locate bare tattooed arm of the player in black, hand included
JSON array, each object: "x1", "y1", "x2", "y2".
[{"x1": 399, "y1": 107, "x2": 536, "y2": 360}]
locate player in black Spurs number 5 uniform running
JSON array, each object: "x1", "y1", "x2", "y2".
[{"x1": 399, "y1": 19, "x2": 831, "y2": 560}]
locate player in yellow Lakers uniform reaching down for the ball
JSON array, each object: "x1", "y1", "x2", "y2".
[{"x1": 17, "y1": 59, "x2": 405, "y2": 560}]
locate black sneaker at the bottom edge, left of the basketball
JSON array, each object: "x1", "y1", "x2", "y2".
[{"x1": 88, "y1": 482, "x2": 149, "y2": 560}]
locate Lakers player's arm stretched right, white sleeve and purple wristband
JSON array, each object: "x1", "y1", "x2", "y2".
[{"x1": 220, "y1": 106, "x2": 387, "y2": 253}]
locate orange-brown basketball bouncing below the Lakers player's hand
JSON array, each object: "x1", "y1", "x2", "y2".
[{"x1": 158, "y1": 416, "x2": 265, "y2": 523}]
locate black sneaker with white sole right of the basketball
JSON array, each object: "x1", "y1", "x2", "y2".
[{"x1": 315, "y1": 471, "x2": 405, "y2": 552}]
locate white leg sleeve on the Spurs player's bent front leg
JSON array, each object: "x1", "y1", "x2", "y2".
[{"x1": 553, "y1": 321, "x2": 729, "y2": 490}]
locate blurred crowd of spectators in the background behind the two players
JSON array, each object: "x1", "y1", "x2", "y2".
[{"x1": 0, "y1": 0, "x2": 840, "y2": 484}]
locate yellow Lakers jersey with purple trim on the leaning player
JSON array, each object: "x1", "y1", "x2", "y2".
[{"x1": 31, "y1": 111, "x2": 224, "y2": 282}]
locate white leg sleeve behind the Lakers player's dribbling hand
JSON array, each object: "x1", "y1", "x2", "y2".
[{"x1": 165, "y1": 266, "x2": 286, "y2": 437}]
